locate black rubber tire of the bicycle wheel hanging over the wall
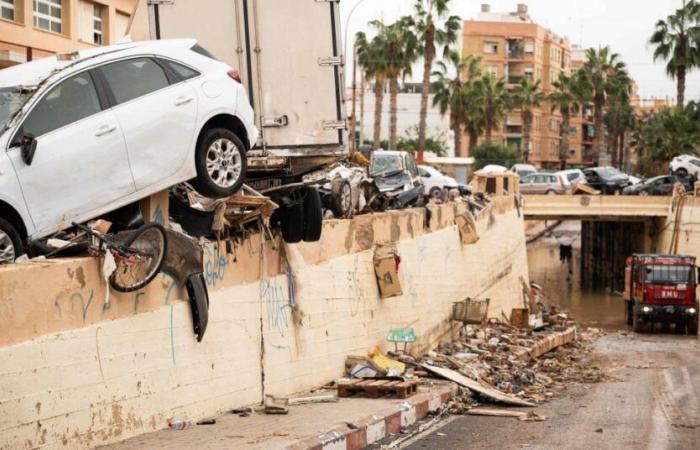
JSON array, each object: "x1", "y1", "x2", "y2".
[{"x1": 109, "y1": 222, "x2": 168, "y2": 292}]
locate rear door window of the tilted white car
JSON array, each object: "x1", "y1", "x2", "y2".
[{"x1": 101, "y1": 58, "x2": 169, "y2": 104}]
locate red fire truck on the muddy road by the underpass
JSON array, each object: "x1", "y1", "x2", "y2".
[{"x1": 625, "y1": 254, "x2": 698, "y2": 335}]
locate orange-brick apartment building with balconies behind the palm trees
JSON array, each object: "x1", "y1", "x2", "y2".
[{"x1": 463, "y1": 4, "x2": 577, "y2": 168}]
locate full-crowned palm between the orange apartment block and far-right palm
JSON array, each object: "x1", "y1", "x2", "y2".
[{"x1": 577, "y1": 46, "x2": 629, "y2": 163}]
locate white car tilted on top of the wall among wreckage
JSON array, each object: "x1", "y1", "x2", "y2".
[{"x1": 0, "y1": 39, "x2": 258, "y2": 262}]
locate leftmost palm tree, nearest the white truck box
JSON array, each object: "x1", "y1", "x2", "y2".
[{"x1": 355, "y1": 32, "x2": 387, "y2": 149}]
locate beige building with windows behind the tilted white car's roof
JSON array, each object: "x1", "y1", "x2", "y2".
[{"x1": 0, "y1": 0, "x2": 136, "y2": 68}]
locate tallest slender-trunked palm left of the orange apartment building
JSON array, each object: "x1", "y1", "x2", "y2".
[{"x1": 413, "y1": 0, "x2": 461, "y2": 162}]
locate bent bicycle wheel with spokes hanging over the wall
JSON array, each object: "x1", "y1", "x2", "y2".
[{"x1": 109, "y1": 223, "x2": 168, "y2": 292}]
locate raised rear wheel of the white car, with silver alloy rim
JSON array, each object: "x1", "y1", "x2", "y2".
[{"x1": 192, "y1": 128, "x2": 248, "y2": 198}]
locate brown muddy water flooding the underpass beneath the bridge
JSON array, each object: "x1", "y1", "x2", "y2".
[{"x1": 527, "y1": 222, "x2": 626, "y2": 330}]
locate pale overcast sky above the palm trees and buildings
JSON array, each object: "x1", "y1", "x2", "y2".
[{"x1": 340, "y1": 0, "x2": 700, "y2": 99}]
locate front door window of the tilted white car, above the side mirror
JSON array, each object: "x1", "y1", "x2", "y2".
[{"x1": 22, "y1": 72, "x2": 102, "y2": 137}]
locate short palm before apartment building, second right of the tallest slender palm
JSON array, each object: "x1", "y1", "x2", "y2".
[{"x1": 474, "y1": 73, "x2": 511, "y2": 142}]
